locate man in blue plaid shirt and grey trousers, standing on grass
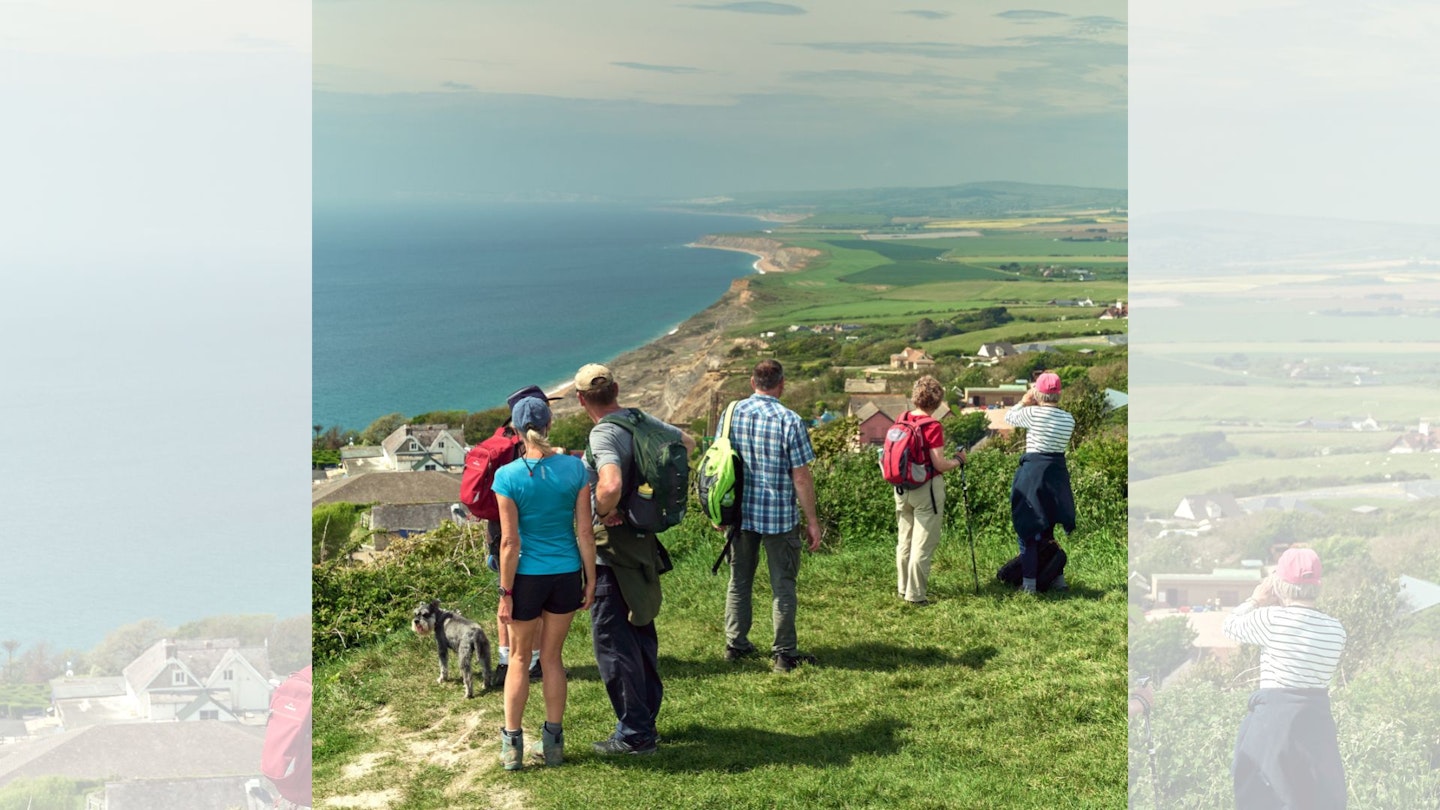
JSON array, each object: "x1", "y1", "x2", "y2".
[{"x1": 724, "y1": 360, "x2": 824, "y2": 672}]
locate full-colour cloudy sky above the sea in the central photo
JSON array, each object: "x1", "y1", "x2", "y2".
[{"x1": 314, "y1": 0, "x2": 1126, "y2": 203}]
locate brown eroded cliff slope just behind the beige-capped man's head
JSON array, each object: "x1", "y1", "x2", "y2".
[{"x1": 554, "y1": 273, "x2": 760, "y2": 424}]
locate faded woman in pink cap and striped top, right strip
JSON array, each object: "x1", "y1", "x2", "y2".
[{"x1": 1224, "y1": 549, "x2": 1345, "y2": 810}]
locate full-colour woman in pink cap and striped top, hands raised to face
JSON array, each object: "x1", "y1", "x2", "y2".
[{"x1": 1005, "y1": 372, "x2": 1076, "y2": 594}]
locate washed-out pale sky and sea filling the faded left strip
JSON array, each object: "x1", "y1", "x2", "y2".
[{"x1": 0, "y1": 0, "x2": 311, "y2": 653}]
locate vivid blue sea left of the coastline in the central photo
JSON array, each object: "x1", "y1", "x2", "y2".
[{"x1": 312, "y1": 203, "x2": 760, "y2": 430}]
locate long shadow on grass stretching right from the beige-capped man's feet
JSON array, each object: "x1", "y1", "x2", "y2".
[{"x1": 596, "y1": 719, "x2": 906, "y2": 774}]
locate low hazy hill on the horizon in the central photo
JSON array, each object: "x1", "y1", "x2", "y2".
[{"x1": 675, "y1": 182, "x2": 1128, "y2": 219}]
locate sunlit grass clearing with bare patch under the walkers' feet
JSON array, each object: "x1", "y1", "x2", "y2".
[{"x1": 314, "y1": 507, "x2": 1126, "y2": 809}]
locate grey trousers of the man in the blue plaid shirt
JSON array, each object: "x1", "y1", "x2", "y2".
[{"x1": 724, "y1": 529, "x2": 801, "y2": 654}]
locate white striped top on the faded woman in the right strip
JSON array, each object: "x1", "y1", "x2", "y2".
[{"x1": 1224, "y1": 601, "x2": 1345, "y2": 689}]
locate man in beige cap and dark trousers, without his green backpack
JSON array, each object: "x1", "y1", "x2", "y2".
[{"x1": 575, "y1": 363, "x2": 696, "y2": 754}]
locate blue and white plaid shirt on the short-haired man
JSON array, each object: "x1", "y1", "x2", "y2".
[{"x1": 730, "y1": 393, "x2": 815, "y2": 535}]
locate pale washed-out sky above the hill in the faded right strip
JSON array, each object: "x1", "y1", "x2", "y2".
[{"x1": 1129, "y1": 0, "x2": 1440, "y2": 223}]
